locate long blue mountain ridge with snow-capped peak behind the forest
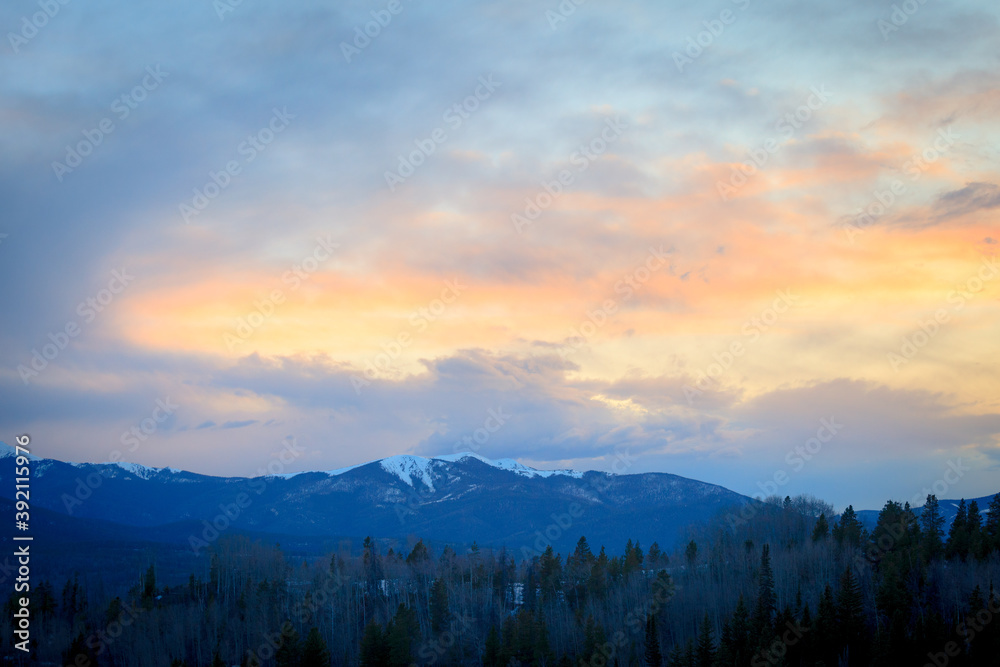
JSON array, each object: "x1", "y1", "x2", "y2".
[{"x1": 0, "y1": 443, "x2": 750, "y2": 557}]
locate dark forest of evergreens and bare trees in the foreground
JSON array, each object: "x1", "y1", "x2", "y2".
[{"x1": 0, "y1": 495, "x2": 1000, "y2": 667}]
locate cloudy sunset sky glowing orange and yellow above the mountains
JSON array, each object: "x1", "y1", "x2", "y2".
[{"x1": 0, "y1": 0, "x2": 1000, "y2": 509}]
